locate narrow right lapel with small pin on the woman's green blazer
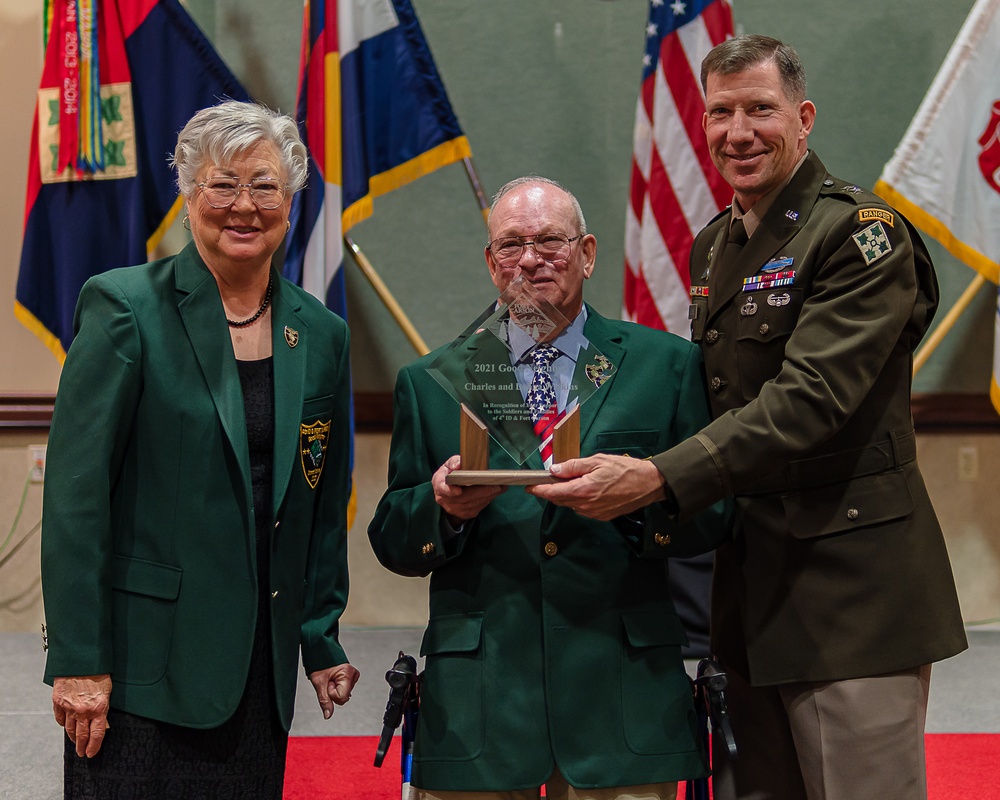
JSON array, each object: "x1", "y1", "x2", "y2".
[{"x1": 271, "y1": 282, "x2": 309, "y2": 514}]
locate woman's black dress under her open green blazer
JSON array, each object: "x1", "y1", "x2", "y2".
[{"x1": 64, "y1": 358, "x2": 288, "y2": 800}]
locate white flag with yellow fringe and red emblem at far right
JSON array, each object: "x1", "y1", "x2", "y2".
[{"x1": 875, "y1": 0, "x2": 1000, "y2": 412}]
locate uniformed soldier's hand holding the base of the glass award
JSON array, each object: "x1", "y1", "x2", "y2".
[{"x1": 525, "y1": 454, "x2": 667, "y2": 521}]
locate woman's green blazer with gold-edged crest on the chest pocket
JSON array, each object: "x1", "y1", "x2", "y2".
[{"x1": 42, "y1": 244, "x2": 350, "y2": 729}]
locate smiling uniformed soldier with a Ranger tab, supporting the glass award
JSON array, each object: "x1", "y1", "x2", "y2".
[{"x1": 531, "y1": 36, "x2": 966, "y2": 800}]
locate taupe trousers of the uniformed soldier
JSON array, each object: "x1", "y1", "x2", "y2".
[{"x1": 712, "y1": 665, "x2": 931, "y2": 800}]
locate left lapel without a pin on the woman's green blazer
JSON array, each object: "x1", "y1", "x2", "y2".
[{"x1": 175, "y1": 243, "x2": 250, "y2": 502}]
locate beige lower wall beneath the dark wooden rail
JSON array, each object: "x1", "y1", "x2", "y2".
[{"x1": 0, "y1": 434, "x2": 1000, "y2": 631}]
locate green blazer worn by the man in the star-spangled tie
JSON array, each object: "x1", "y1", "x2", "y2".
[{"x1": 368, "y1": 308, "x2": 725, "y2": 791}]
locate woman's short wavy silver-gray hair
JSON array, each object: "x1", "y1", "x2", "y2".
[{"x1": 170, "y1": 100, "x2": 309, "y2": 197}]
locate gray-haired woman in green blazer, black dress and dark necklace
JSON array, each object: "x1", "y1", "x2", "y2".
[{"x1": 42, "y1": 102, "x2": 358, "y2": 800}]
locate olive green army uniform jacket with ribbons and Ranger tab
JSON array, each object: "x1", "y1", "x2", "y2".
[{"x1": 654, "y1": 153, "x2": 966, "y2": 685}]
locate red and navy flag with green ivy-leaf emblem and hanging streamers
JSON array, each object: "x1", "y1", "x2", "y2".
[{"x1": 14, "y1": 0, "x2": 249, "y2": 361}]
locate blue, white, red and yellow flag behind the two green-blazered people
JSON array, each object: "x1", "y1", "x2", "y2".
[{"x1": 284, "y1": 0, "x2": 471, "y2": 316}]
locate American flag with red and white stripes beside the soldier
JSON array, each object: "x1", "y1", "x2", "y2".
[{"x1": 624, "y1": 0, "x2": 733, "y2": 335}]
